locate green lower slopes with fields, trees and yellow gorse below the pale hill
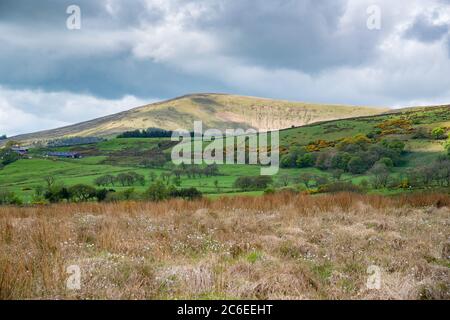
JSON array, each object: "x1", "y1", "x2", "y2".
[{"x1": 0, "y1": 106, "x2": 450, "y2": 203}]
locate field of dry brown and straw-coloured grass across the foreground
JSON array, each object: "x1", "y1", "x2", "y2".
[{"x1": 0, "y1": 193, "x2": 450, "y2": 299}]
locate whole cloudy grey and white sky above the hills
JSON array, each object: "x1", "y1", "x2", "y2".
[{"x1": 0, "y1": 0, "x2": 450, "y2": 136}]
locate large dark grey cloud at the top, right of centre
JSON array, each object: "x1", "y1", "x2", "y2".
[{"x1": 195, "y1": 0, "x2": 383, "y2": 73}]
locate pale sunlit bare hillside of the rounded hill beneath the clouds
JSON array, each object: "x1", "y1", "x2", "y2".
[{"x1": 4, "y1": 94, "x2": 386, "y2": 142}]
